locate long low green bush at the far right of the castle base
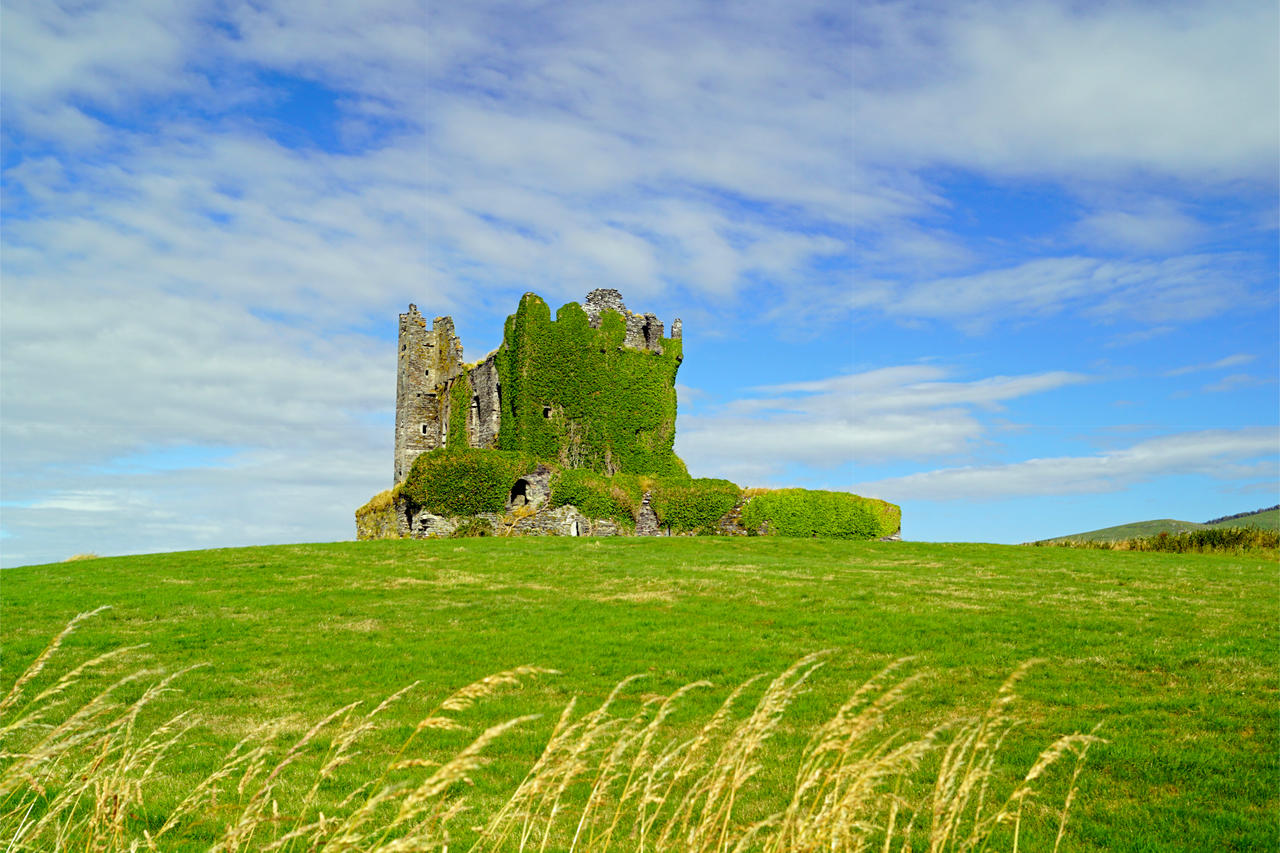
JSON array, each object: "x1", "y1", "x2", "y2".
[{"x1": 741, "y1": 489, "x2": 901, "y2": 539}]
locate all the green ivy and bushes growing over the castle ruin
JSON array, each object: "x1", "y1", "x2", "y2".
[{"x1": 386, "y1": 293, "x2": 901, "y2": 539}]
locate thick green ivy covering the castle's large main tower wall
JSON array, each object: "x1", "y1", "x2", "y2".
[{"x1": 495, "y1": 293, "x2": 689, "y2": 478}]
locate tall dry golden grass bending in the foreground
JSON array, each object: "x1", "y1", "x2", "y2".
[{"x1": 0, "y1": 611, "x2": 1098, "y2": 853}]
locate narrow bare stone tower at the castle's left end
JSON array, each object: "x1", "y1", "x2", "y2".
[{"x1": 393, "y1": 305, "x2": 462, "y2": 483}]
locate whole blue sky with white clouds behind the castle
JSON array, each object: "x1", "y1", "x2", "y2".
[{"x1": 0, "y1": 0, "x2": 1280, "y2": 566}]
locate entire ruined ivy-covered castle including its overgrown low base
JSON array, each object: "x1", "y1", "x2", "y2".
[{"x1": 356, "y1": 289, "x2": 901, "y2": 539}]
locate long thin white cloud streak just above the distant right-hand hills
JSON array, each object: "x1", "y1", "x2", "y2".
[{"x1": 854, "y1": 427, "x2": 1280, "y2": 501}]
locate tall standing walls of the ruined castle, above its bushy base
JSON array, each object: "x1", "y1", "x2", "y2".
[{"x1": 394, "y1": 288, "x2": 682, "y2": 483}]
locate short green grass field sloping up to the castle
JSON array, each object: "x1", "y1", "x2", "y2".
[{"x1": 0, "y1": 538, "x2": 1280, "y2": 850}]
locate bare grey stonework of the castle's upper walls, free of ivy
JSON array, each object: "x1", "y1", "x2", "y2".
[{"x1": 394, "y1": 288, "x2": 682, "y2": 483}]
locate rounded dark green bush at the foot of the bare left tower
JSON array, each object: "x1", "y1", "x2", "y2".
[{"x1": 401, "y1": 446, "x2": 538, "y2": 516}]
